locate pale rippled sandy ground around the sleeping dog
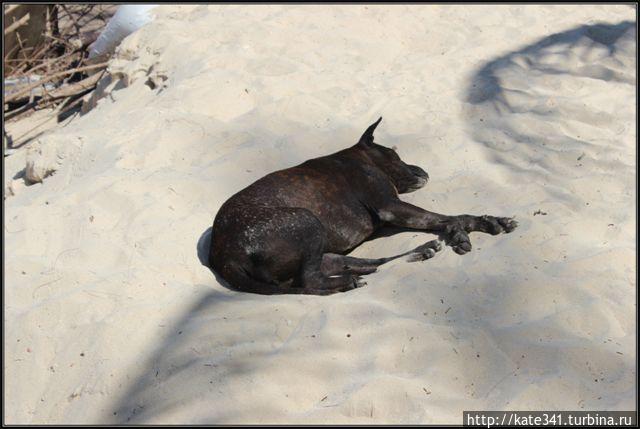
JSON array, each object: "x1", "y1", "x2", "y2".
[{"x1": 4, "y1": 5, "x2": 637, "y2": 424}]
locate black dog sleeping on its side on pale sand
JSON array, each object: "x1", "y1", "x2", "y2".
[{"x1": 209, "y1": 118, "x2": 517, "y2": 295}]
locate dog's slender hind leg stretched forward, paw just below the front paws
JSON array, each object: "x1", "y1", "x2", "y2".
[{"x1": 321, "y1": 240, "x2": 442, "y2": 276}]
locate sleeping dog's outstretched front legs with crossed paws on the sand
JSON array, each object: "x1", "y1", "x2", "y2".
[{"x1": 377, "y1": 200, "x2": 518, "y2": 255}]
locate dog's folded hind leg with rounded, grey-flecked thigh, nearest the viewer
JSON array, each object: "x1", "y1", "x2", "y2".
[{"x1": 215, "y1": 206, "x2": 362, "y2": 295}]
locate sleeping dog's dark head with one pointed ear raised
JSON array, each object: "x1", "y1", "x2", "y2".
[{"x1": 358, "y1": 117, "x2": 429, "y2": 194}]
